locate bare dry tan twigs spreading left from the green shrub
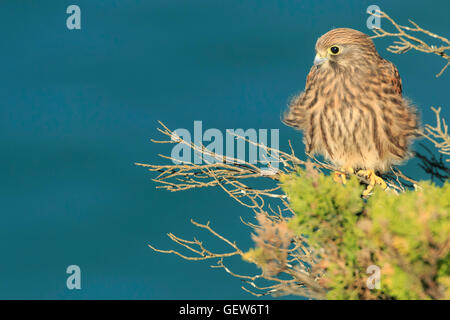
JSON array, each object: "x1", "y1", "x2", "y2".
[{"x1": 140, "y1": 122, "x2": 422, "y2": 299}]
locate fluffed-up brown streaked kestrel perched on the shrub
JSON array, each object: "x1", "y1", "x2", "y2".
[{"x1": 283, "y1": 28, "x2": 418, "y2": 194}]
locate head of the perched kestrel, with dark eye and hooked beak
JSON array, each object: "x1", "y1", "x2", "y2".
[{"x1": 314, "y1": 28, "x2": 378, "y2": 67}]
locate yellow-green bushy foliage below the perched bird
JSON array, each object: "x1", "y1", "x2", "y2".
[{"x1": 282, "y1": 170, "x2": 450, "y2": 299}]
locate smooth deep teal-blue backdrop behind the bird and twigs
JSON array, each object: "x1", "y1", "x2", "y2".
[{"x1": 0, "y1": 0, "x2": 450, "y2": 299}]
